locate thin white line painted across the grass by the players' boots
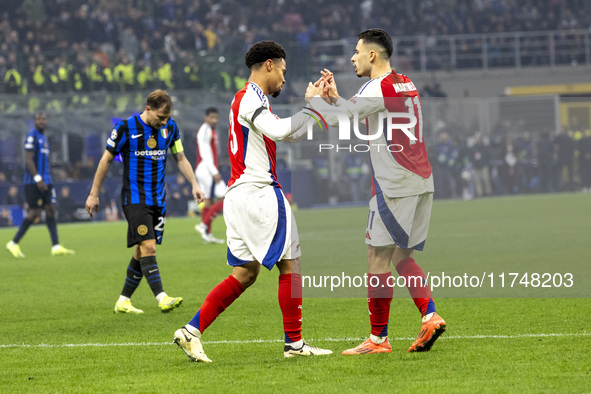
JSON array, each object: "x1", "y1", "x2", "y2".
[{"x1": 0, "y1": 332, "x2": 591, "y2": 349}]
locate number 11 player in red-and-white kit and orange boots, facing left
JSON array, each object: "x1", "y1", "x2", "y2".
[{"x1": 307, "y1": 29, "x2": 446, "y2": 355}]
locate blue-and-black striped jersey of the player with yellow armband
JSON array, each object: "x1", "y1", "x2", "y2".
[{"x1": 107, "y1": 115, "x2": 183, "y2": 207}]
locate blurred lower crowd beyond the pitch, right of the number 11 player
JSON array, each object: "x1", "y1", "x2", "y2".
[{"x1": 429, "y1": 122, "x2": 591, "y2": 199}]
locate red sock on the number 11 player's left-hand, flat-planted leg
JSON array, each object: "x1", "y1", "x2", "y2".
[{"x1": 367, "y1": 272, "x2": 394, "y2": 337}]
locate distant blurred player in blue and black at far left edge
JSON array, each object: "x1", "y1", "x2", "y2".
[{"x1": 6, "y1": 112, "x2": 74, "y2": 258}]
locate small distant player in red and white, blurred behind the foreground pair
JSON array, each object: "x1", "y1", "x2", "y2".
[{"x1": 195, "y1": 107, "x2": 226, "y2": 244}]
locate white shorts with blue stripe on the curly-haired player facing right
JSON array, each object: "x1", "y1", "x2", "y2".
[{"x1": 224, "y1": 184, "x2": 302, "y2": 270}]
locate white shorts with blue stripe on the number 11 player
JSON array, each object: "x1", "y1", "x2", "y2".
[{"x1": 365, "y1": 193, "x2": 433, "y2": 250}]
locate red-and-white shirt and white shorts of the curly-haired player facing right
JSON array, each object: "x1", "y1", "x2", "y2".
[{"x1": 224, "y1": 82, "x2": 309, "y2": 270}]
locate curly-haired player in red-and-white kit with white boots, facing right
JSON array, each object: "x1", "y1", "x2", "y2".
[{"x1": 174, "y1": 41, "x2": 332, "y2": 362}]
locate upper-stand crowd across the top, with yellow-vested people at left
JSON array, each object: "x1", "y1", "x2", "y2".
[{"x1": 0, "y1": 0, "x2": 589, "y2": 94}]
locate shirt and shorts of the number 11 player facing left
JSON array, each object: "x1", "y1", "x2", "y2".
[{"x1": 311, "y1": 71, "x2": 434, "y2": 250}]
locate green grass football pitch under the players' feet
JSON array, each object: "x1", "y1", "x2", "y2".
[{"x1": 0, "y1": 194, "x2": 591, "y2": 393}]
